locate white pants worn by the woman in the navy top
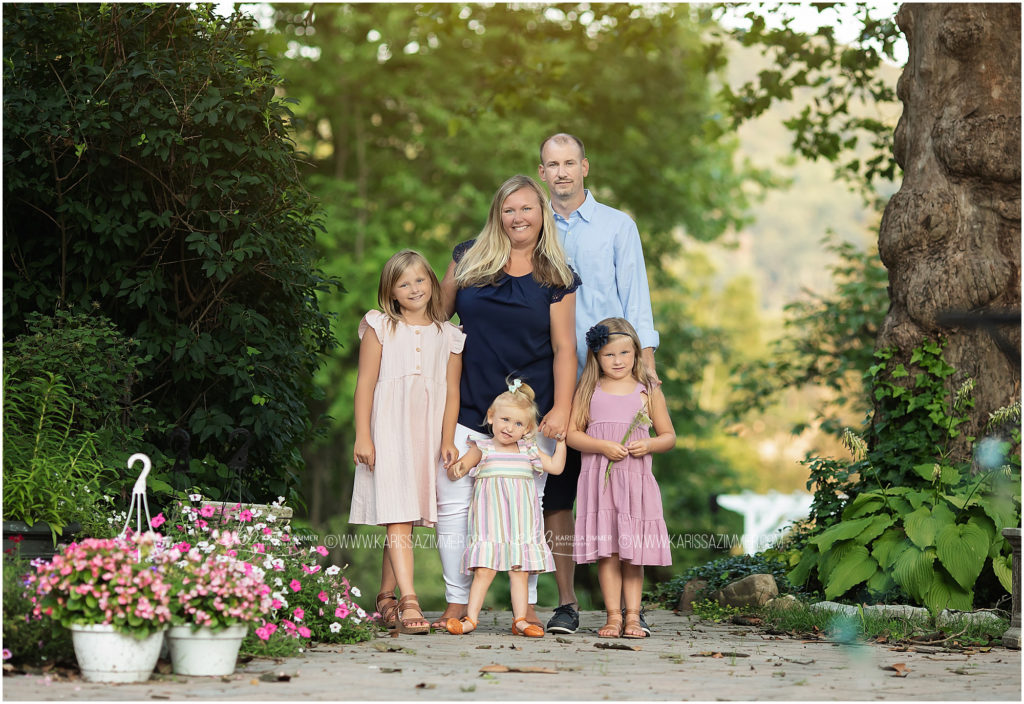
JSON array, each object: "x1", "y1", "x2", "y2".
[{"x1": 436, "y1": 425, "x2": 555, "y2": 604}]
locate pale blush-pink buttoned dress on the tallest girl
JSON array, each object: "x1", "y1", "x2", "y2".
[{"x1": 348, "y1": 310, "x2": 466, "y2": 527}]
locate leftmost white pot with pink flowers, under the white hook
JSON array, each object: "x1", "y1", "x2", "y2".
[{"x1": 27, "y1": 533, "x2": 171, "y2": 681}]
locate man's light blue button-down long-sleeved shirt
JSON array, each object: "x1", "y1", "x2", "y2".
[{"x1": 555, "y1": 190, "x2": 659, "y2": 373}]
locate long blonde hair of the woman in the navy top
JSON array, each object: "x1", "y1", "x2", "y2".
[{"x1": 455, "y1": 174, "x2": 572, "y2": 289}]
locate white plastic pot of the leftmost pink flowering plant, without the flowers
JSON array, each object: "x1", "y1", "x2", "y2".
[{"x1": 71, "y1": 624, "x2": 164, "y2": 683}]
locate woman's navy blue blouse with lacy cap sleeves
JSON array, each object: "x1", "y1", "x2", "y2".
[{"x1": 452, "y1": 239, "x2": 583, "y2": 430}]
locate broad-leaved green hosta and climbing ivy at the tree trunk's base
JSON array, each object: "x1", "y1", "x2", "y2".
[{"x1": 790, "y1": 342, "x2": 1020, "y2": 614}]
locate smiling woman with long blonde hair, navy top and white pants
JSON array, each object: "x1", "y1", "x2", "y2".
[{"x1": 431, "y1": 175, "x2": 581, "y2": 628}]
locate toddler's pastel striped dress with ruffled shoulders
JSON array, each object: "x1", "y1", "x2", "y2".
[{"x1": 462, "y1": 437, "x2": 555, "y2": 574}]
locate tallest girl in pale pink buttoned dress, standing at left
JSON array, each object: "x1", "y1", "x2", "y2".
[{"x1": 348, "y1": 250, "x2": 466, "y2": 633}]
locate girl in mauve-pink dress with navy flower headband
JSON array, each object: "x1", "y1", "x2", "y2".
[{"x1": 568, "y1": 318, "x2": 676, "y2": 637}]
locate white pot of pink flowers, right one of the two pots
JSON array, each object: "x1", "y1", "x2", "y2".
[{"x1": 164, "y1": 529, "x2": 271, "y2": 675}]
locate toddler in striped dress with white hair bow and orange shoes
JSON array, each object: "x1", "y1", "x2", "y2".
[{"x1": 445, "y1": 379, "x2": 565, "y2": 637}]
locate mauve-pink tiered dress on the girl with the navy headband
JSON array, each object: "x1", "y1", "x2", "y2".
[{"x1": 572, "y1": 384, "x2": 672, "y2": 565}]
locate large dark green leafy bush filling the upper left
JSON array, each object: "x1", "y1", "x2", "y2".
[{"x1": 3, "y1": 3, "x2": 333, "y2": 503}]
